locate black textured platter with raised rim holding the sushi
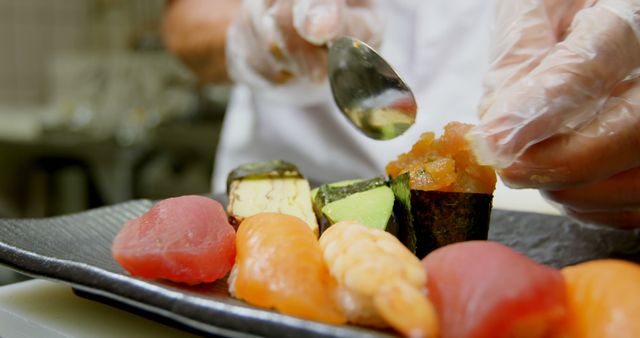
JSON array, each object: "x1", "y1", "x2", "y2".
[{"x1": 0, "y1": 201, "x2": 640, "y2": 337}]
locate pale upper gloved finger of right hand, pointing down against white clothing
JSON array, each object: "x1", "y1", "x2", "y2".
[{"x1": 479, "y1": 0, "x2": 594, "y2": 116}]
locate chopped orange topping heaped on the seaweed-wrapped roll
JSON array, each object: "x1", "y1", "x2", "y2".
[{"x1": 386, "y1": 122, "x2": 496, "y2": 194}]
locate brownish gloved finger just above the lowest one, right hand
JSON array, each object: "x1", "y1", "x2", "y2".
[{"x1": 499, "y1": 78, "x2": 640, "y2": 189}]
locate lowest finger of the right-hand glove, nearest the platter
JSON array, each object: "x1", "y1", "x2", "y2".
[{"x1": 541, "y1": 167, "x2": 640, "y2": 212}]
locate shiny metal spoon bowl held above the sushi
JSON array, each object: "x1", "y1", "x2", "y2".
[{"x1": 329, "y1": 37, "x2": 417, "y2": 140}]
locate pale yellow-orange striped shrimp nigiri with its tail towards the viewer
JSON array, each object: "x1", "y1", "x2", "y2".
[{"x1": 320, "y1": 221, "x2": 438, "y2": 337}]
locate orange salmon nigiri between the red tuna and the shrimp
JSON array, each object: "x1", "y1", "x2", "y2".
[{"x1": 229, "y1": 213, "x2": 346, "y2": 324}]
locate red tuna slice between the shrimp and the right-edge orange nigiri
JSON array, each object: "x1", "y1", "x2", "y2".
[{"x1": 422, "y1": 241, "x2": 566, "y2": 338}]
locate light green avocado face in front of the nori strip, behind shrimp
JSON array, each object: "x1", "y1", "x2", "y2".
[{"x1": 322, "y1": 185, "x2": 394, "y2": 230}]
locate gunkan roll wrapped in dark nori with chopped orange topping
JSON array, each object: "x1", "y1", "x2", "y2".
[{"x1": 386, "y1": 122, "x2": 496, "y2": 258}]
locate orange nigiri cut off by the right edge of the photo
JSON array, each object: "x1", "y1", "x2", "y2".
[{"x1": 560, "y1": 259, "x2": 640, "y2": 338}]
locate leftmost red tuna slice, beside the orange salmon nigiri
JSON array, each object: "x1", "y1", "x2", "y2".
[{"x1": 111, "y1": 196, "x2": 236, "y2": 284}]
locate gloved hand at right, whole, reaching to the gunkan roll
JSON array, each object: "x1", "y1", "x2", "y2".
[{"x1": 468, "y1": 0, "x2": 640, "y2": 228}]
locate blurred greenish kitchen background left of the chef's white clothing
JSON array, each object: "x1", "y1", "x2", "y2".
[{"x1": 0, "y1": 0, "x2": 228, "y2": 282}]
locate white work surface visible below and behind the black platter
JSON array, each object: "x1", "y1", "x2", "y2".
[{"x1": 0, "y1": 184, "x2": 558, "y2": 338}]
